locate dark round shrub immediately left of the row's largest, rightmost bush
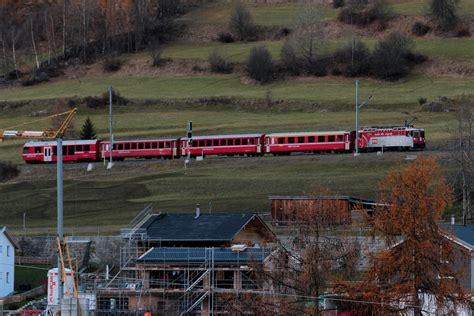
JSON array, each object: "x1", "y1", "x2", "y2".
[{"x1": 334, "y1": 39, "x2": 370, "y2": 77}]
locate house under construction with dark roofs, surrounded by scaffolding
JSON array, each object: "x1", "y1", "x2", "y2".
[{"x1": 96, "y1": 208, "x2": 276, "y2": 315}]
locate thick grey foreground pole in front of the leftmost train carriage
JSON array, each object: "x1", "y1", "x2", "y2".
[{"x1": 56, "y1": 135, "x2": 64, "y2": 309}]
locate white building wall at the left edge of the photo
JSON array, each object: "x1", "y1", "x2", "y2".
[{"x1": 0, "y1": 226, "x2": 17, "y2": 297}]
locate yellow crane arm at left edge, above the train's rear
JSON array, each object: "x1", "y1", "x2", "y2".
[{"x1": 0, "y1": 108, "x2": 77, "y2": 142}]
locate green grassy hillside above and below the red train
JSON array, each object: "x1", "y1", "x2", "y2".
[{"x1": 0, "y1": 0, "x2": 474, "y2": 232}]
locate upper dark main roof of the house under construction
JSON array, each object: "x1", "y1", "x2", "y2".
[{"x1": 141, "y1": 213, "x2": 256, "y2": 241}]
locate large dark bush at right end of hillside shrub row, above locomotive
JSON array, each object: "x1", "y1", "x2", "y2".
[{"x1": 372, "y1": 32, "x2": 414, "y2": 80}]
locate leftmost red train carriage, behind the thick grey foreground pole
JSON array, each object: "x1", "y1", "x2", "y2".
[{"x1": 22, "y1": 139, "x2": 100, "y2": 163}]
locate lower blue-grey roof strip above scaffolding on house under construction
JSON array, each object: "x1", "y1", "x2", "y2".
[{"x1": 138, "y1": 247, "x2": 271, "y2": 264}]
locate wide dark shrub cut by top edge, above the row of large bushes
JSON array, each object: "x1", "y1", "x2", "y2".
[{"x1": 338, "y1": 0, "x2": 393, "y2": 26}]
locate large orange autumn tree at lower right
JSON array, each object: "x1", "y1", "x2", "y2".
[{"x1": 339, "y1": 158, "x2": 467, "y2": 315}]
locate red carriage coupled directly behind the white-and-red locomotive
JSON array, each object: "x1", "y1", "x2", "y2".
[{"x1": 265, "y1": 131, "x2": 353, "y2": 155}]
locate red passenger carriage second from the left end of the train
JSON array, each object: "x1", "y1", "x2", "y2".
[{"x1": 101, "y1": 139, "x2": 179, "y2": 160}]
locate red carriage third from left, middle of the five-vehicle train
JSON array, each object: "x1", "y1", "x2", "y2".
[{"x1": 180, "y1": 134, "x2": 264, "y2": 157}]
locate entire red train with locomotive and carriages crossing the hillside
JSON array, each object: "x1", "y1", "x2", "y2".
[{"x1": 23, "y1": 126, "x2": 425, "y2": 163}]
